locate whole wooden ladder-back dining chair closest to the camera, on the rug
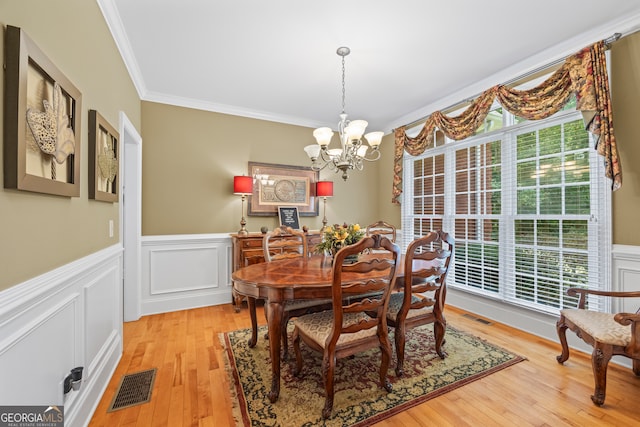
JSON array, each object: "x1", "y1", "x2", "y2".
[{"x1": 292, "y1": 235, "x2": 400, "y2": 418}]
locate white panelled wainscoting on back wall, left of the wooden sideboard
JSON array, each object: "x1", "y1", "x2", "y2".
[{"x1": 141, "y1": 234, "x2": 232, "y2": 315}]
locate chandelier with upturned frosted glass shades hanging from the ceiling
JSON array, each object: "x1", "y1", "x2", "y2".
[{"x1": 304, "y1": 47, "x2": 384, "y2": 181}]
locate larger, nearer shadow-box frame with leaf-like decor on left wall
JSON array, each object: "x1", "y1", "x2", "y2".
[{"x1": 3, "y1": 25, "x2": 82, "y2": 197}]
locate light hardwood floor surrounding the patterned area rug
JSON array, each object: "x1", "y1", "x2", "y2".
[{"x1": 90, "y1": 304, "x2": 640, "y2": 427}]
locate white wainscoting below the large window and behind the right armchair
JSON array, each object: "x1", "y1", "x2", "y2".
[{"x1": 447, "y1": 245, "x2": 640, "y2": 366}]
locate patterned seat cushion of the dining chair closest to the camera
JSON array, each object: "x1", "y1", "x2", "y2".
[{"x1": 293, "y1": 310, "x2": 376, "y2": 348}]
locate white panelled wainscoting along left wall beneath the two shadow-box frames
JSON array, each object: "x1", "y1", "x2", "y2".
[{"x1": 0, "y1": 245, "x2": 122, "y2": 426}]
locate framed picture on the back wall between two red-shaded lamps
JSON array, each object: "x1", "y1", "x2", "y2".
[{"x1": 247, "y1": 162, "x2": 319, "y2": 216}]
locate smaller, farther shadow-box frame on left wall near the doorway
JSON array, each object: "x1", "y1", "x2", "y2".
[{"x1": 88, "y1": 110, "x2": 120, "y2": 203}]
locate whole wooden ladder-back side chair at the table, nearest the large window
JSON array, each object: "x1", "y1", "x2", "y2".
[{"x1": 387, "y1": 231, "x2": 454, "y2": 377}]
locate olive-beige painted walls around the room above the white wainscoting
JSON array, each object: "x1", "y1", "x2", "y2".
[{"x1": 0, "y1": 0, "x2": 640, "y2": 290}]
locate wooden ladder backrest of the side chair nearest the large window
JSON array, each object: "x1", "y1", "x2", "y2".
[{"x1": 399, "y1": 230, "x2": 455, "y2": 317}]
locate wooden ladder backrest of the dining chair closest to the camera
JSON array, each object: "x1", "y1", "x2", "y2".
[{"x1": 330, "y1": 235, "x2": 400, "y2": 345}]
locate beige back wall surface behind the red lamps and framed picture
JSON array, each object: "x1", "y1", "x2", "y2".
[{"x1": 142, "y1": 102, "x2": 400, "y2": 235}]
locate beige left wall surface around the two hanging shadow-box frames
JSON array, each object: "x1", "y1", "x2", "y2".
[{"x1": 0, "y1": 0, "x2": 140, "y2": 290}]
